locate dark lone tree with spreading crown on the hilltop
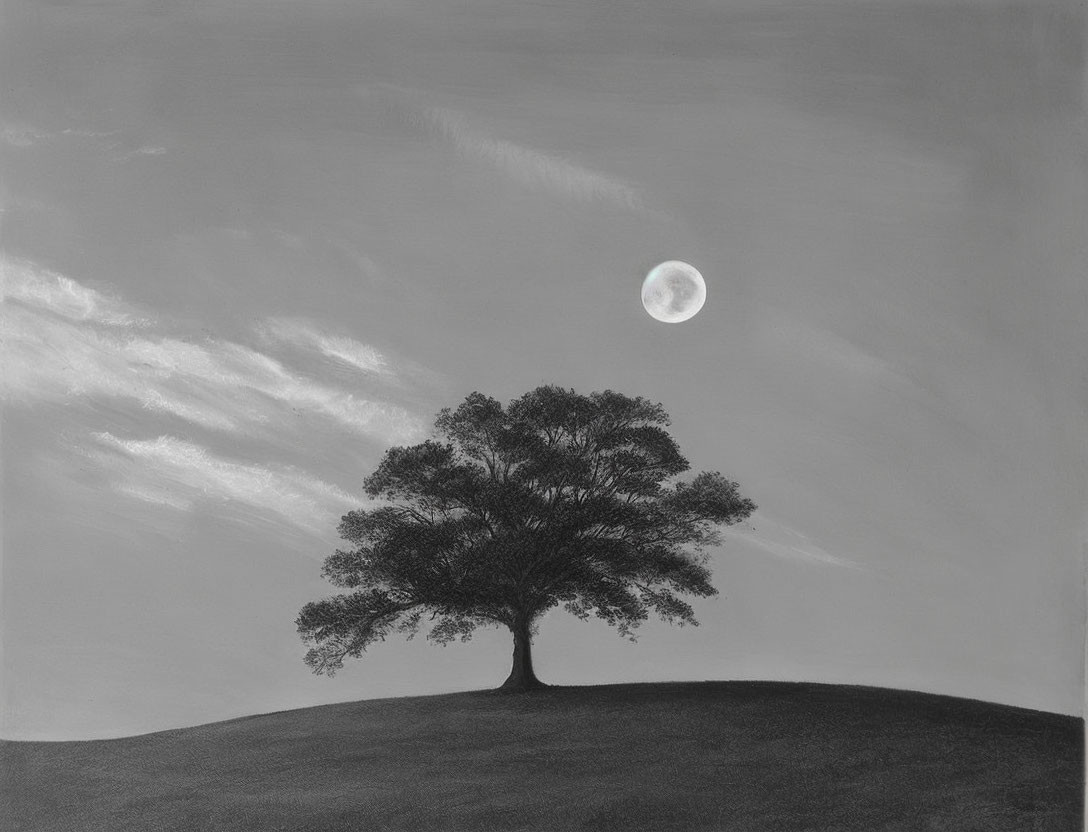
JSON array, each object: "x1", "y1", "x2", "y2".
[{"x1": 296, "y1": 386, "x2": 755, "y2": 691}]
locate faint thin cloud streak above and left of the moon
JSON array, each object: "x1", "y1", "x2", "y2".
[{"x1": 424, "y1": 108, "x2": 647, "y2": 213}]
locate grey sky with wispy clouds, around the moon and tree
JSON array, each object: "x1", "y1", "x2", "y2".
[{"x1": 0, "y1": 0, "x2": 1088, "y2": 740}]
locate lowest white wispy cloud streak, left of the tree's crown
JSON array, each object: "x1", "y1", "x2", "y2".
[{"x1": 84, "y1": 432, "x2": 361, "y2": 534}]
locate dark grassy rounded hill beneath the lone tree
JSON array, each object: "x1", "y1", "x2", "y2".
[{"x1": 0, "y1": 682, "x2": 1084, "y2": 832}]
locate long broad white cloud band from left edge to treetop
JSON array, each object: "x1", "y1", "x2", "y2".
[{"x1": 2, "y1": 263, "x2": 422, "y2": 444}]
